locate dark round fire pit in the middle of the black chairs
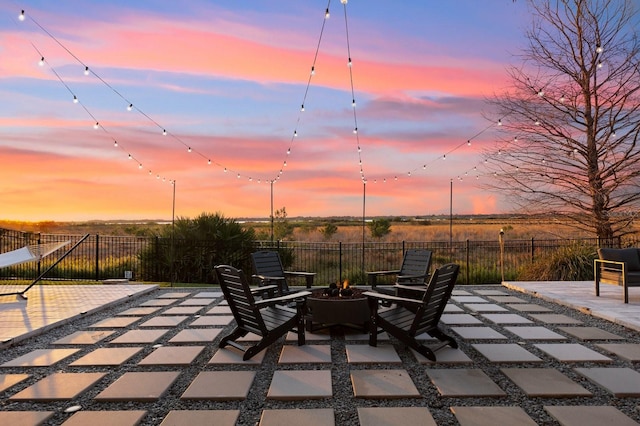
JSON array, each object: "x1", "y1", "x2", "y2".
[{"x1": 306, "y1": 285, "x2": 370, "y2": 331}]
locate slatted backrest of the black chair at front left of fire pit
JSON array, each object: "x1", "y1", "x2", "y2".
[{"x1": 215, "y1": 265, "x2": 267, "y2": 336}]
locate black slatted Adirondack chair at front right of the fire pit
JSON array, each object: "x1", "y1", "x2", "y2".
[{"x1": 365, "y1": 263, "x2": 460, "y2": 361}]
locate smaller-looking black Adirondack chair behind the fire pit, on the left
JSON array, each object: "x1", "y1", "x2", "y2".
[{"x1": 251, "y1": 250, "x2": 316, "y2": 296}]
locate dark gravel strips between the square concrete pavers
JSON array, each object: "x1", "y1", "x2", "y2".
[{"x1": 0, "y1": 286, "x2": 640, "y2": 425}]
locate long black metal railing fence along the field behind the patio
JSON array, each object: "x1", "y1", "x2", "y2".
[{"x1": 0, "y1": 229, "x2": 637, "y2": 285}]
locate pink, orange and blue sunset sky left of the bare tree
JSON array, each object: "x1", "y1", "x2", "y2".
[{"x1": 0, "y1": 0, "x2": 530, "y2": 221}]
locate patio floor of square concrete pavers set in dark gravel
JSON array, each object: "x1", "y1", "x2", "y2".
[{"x1": 0, "y1": 282, "x2": 640, "y2": 426}]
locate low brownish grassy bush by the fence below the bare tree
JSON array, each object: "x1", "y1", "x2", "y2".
[{"x1": 518, "y1": 244, "x2": 597, "y2": 281}]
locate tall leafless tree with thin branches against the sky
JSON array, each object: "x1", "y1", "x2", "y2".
[{"x1": 485, "y1": 0, "x2": 640, "y2": 239}]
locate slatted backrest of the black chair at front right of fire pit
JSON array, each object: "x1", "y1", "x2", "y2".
[{"x1": 410, "y1": 263, "x2": 460, "y2": 335}]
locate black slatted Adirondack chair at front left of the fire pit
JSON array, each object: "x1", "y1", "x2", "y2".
[{"x1": 215, "y1": 265, "x2": 311, "y2": 361}]
